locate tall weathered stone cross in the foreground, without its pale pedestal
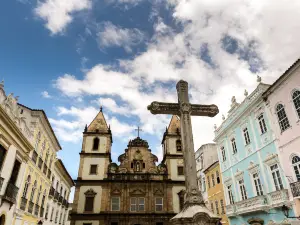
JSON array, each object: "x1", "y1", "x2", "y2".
[{"x1": 148, "y1": 80, "x2": 219, "y2": 224}]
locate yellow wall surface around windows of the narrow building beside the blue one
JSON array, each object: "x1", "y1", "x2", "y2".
[{"x1": 205, "y1": 163, "x2": 229, "y2": 225}]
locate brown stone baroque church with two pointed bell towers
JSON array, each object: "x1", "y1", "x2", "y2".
[{"x1": 70, "y1": 109, "x2": 185, "y2": 225}]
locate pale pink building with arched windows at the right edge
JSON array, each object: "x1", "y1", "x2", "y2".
[{"x1": 263, "y1": 59, "x2": 300, "y2": 216}]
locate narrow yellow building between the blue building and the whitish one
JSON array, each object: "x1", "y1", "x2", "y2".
[{"x1": 204, "y1": 161, "x2": 229, "y2": 225}]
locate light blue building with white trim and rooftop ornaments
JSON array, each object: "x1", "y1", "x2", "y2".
[{"x1": 214, "y1": 78, "x2": 294, "y2": 225}]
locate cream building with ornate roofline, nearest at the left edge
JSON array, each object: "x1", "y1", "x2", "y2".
[{"x1": 0, "y1": 82, "x2": 33, "y2": 225}]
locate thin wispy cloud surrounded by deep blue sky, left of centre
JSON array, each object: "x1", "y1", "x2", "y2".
[{"x1": 97, "y1": 22, "x2": 145, "y2": 52}]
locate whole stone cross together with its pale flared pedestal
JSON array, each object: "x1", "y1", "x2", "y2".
[{"x1": 148, "y1": 80, "x2": 220, "y2": 225}]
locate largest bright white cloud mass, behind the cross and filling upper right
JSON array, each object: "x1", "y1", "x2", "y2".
[{"x1": 56, "y1": 0, "x2": 300, "y2": 151}]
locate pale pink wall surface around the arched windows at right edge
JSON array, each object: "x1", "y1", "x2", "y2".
[{"x1": 266, "y1": 63, "x2": 300, "y2": 216}]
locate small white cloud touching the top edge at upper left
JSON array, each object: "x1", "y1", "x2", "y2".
[{"x1": 34, "y1": 0, "x2": 92, "y2": 34}]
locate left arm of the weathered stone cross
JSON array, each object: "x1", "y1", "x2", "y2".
[{"x1": 147, "y1": 102, "x2": 180, "y2": 115}]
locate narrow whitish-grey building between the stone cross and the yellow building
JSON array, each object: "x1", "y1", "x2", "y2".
[{"x1": 195, "y1": 143, "x2": 218, "y2": 207}]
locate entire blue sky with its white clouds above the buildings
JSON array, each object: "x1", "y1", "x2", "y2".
[{"x1": 0, "y1": 0, "x2": 300, "y2": 186}]
